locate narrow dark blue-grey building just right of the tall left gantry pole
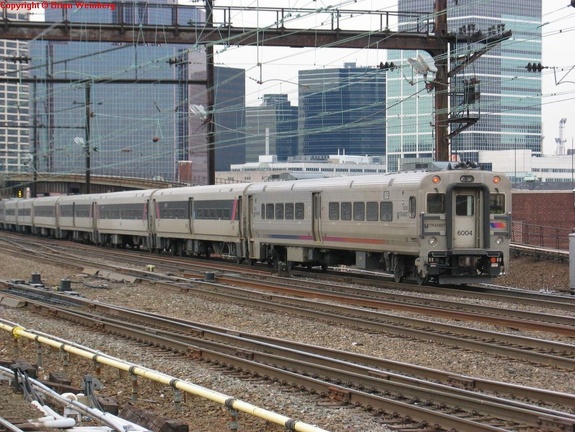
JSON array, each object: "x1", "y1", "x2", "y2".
[{"x1": 214, "y1": 66, "x2": 246, "y2": 171}]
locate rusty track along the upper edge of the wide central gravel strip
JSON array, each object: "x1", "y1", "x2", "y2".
[{"x1": 3, "y1": 282, "x2": 575, "y2": 370}]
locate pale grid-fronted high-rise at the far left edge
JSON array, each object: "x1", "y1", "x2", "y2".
[{"x1": 0, "y1": 12, "x2": 32, "y2": 173}]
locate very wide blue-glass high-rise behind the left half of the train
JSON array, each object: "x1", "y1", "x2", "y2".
[{"x1": 30, "y1": 0, "x2": 208, "y2": 184}]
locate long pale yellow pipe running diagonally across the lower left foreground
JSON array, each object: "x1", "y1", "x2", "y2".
[{"x1": 0, "y1": 322, "x2": 328, "y2": 432}]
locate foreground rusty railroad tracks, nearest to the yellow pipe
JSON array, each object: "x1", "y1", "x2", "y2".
[{"x1": 1, "y1": 299, "x2": 575, "y2": 431}]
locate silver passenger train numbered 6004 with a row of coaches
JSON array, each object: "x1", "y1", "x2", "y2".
[{"x1": 0, "y1": 163, "x2": 511, "y2": 284}]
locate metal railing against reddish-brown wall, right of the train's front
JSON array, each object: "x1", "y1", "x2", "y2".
[{"x1": 511, "y1": 221, "x2": 573, "y2": 250}]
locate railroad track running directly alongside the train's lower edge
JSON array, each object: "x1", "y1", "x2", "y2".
[{"x1": 2, "y1": 237, "x2": 575, "y2": 316}]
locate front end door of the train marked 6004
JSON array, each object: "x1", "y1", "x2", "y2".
[{"x1": 452, "y1": 189, "x2": 483, "y2": 248}]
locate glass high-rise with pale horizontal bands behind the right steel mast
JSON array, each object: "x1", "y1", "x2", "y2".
[{"x1": 387, "y1": 0, "x2": 542, "y2": 171}]
